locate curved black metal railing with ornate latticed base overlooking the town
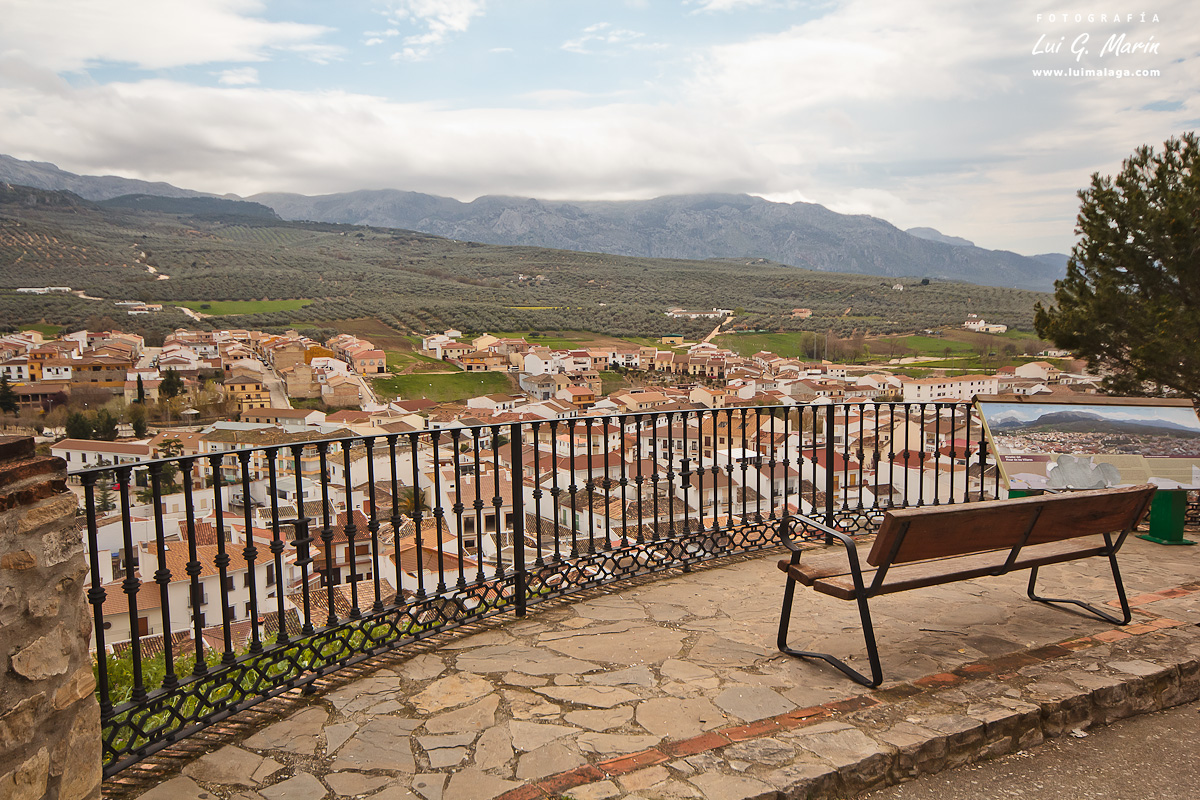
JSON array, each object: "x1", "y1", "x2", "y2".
[{"x1": 72, "y1": 403, "x2": 1000, "y2": 775}]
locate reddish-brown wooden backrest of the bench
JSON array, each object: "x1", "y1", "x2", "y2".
[{"x1": 866, "y1": 483, "x2": 1154, "y2": 566}]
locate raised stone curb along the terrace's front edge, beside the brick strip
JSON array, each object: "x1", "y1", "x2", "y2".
[{"x1": 506, "y1": 597, "x2": 1200, "y2": 800}]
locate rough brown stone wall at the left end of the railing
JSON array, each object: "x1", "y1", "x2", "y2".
[{"x1": 0, "y1": 437, "x2": 101, "y2": 800}]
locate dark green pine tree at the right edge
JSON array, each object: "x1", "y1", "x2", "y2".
[{"x1": 1034, "y1": 133, "x2": 1200, "y2": 399}]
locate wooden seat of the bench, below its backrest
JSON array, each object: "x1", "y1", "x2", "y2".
[{"x1": 779, "y1": 540, "x2": 1105, "y2": 600}]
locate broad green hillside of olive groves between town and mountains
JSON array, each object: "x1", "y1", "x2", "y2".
[{"x1": 0, "y1": 184, "x2": 1046, "y2": 336}]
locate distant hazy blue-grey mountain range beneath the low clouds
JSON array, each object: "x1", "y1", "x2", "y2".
[{"x1": 0, "y1": 156, "x2": 1067, "y2": 290}]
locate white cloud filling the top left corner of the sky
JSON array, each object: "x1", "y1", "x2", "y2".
[{"x1": 0, "y1": 0, "x2": 330, "y2": 72}]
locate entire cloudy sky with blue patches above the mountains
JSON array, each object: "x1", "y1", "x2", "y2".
[{"x1": 0, "y1": 0, "x2": 1200, "y2": 253}]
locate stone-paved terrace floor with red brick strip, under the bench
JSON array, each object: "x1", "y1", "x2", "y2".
[{"x1": 106, "y1": 531, "x2": 1200, "y2": 800}]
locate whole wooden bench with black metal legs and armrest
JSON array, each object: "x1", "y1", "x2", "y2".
[{"x1": 779, "y1": 485, "x2": 1154, "y2": 687}]
